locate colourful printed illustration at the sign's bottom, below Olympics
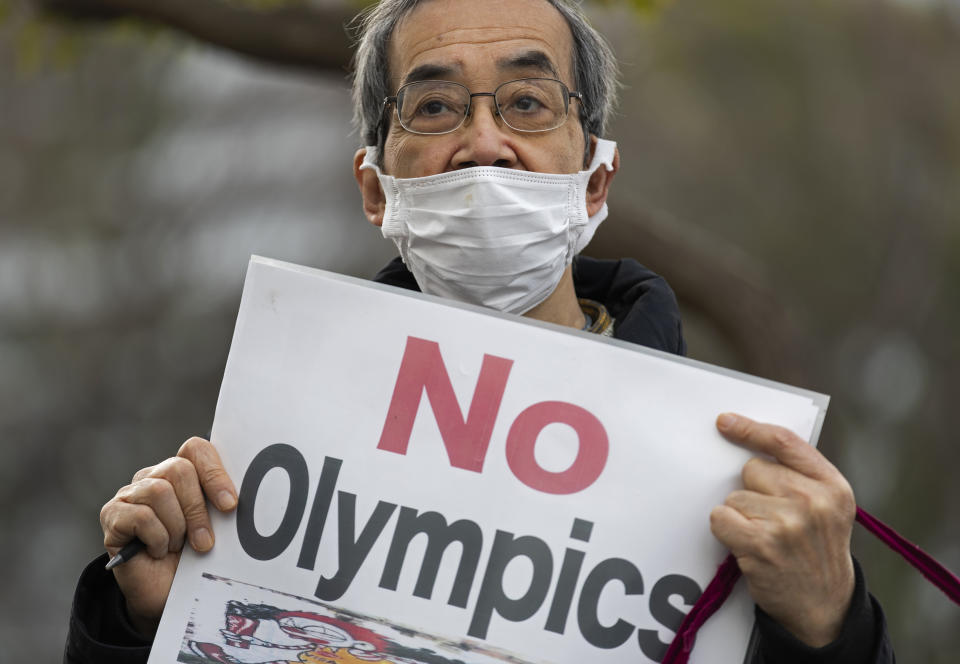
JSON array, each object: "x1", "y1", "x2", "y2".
[{"x1": 177, "y1": 574, "x2": 526, "y2": 664}]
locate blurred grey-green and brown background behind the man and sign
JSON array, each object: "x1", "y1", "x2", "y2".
[{"x1": 0, "y1": 0, "x2": 960, "y2": 664}]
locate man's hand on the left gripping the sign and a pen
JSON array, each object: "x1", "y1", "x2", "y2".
[{"x1": 100, "y1": 438, "x2": 237, "y2": 637}]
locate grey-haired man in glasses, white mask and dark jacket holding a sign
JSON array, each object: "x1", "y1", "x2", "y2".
[{"x1": 65, "y1": 0, "x2": 893, "y2": 664}]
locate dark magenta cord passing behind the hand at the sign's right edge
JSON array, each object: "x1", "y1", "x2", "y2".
[{"x1": 660, "y1": 507, "x2": 960, "y2": 664}]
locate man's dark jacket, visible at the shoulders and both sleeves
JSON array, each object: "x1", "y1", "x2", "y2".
[{"x1": 64, "y1": 256, "x2": 895, "y2": 664}]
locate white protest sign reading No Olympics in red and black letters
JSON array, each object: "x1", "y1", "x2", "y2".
[{"x1": 150, "y1": 258, "x2": 827, "y2": 664}]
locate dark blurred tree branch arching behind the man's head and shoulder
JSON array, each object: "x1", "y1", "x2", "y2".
[{"x1": 33, "y1": 0, "x2": 811, "y2": 384}]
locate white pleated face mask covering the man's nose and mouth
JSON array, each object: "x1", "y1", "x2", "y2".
[{"x1": 360, "y1": 140, "x2": 616, "y2": 314}]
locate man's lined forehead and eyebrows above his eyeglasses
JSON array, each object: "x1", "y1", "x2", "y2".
[{"x1": 390, "y1": 0, "x2": 573, "y2": 89}]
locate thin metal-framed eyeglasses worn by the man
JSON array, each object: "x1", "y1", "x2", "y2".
[{"x1": 383, "y1": 78, "x2": 583, "y2": 134}]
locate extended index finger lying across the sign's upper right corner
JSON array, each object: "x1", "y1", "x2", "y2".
[{"x1": 717, "y1": 413, "x2": 839, "y2": 480}]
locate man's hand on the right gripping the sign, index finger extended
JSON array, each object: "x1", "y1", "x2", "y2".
[{"x1": 710, "y1": 414, "x2": 856, "y2": 647}]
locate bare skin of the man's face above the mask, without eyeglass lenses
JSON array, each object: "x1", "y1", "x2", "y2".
[{"x1": 383, "y1": 0, "x2": 584, "y2": 178}]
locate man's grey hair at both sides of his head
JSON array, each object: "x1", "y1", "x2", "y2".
[{"x1": 353, "y1": 0, "x2": 618, "y2": 163}]
